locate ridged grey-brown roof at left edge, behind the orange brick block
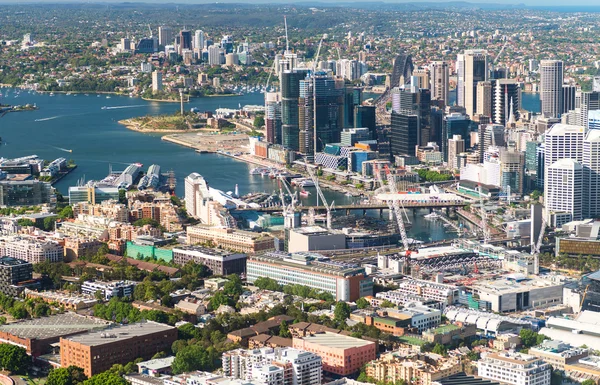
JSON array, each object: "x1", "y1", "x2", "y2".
[{"x1": 0, "y1": 313, "x2": 110, "y2": 340}]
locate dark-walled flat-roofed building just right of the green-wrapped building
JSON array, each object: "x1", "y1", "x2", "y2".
[{"x1": 173, "y1": 246, "x2": 246, "y2": 275}]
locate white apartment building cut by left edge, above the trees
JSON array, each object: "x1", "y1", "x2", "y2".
[{"x1": 0, "y1": 236, "x2": 64, "y2": 263}]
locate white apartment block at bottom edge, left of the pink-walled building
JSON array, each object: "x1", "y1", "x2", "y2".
[{"x1": 222, "y1": 348, "x2": 323, "y2": 385}]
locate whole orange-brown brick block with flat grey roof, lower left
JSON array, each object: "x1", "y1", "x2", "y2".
[{"x1": 60, "y1": 321, "x2": 177, "y2": 377}]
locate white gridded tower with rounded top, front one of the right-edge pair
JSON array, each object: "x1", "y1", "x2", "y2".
[{"x1": 544, "y1": 159, "x2": 583, "y2": 227}]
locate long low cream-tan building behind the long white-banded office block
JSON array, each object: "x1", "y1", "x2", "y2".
[{"x1": 186, "y1": 225, "x2": 275, "y2": 254}]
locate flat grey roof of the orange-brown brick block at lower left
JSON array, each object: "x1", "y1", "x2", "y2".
[{"x1": 66, "y1": 321, "x2": 174, "y2": 346}]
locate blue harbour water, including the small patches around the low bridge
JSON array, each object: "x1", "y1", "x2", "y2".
[{"x1": 0, "y1": 88, "x2": 544, "y2": 241}]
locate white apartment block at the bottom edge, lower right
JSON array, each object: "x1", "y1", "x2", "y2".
[{"x1": 477, "y1": 352, "x2": 552, "y2": 385}]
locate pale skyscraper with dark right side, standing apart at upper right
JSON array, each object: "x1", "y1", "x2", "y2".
[{"x1": 540, "y1": 60, "x2": 564, "y2": 118}]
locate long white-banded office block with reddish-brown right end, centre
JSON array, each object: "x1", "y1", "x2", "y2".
[{"x1": 247, "y1": 253, "x2": 373, "y2": 301}]
